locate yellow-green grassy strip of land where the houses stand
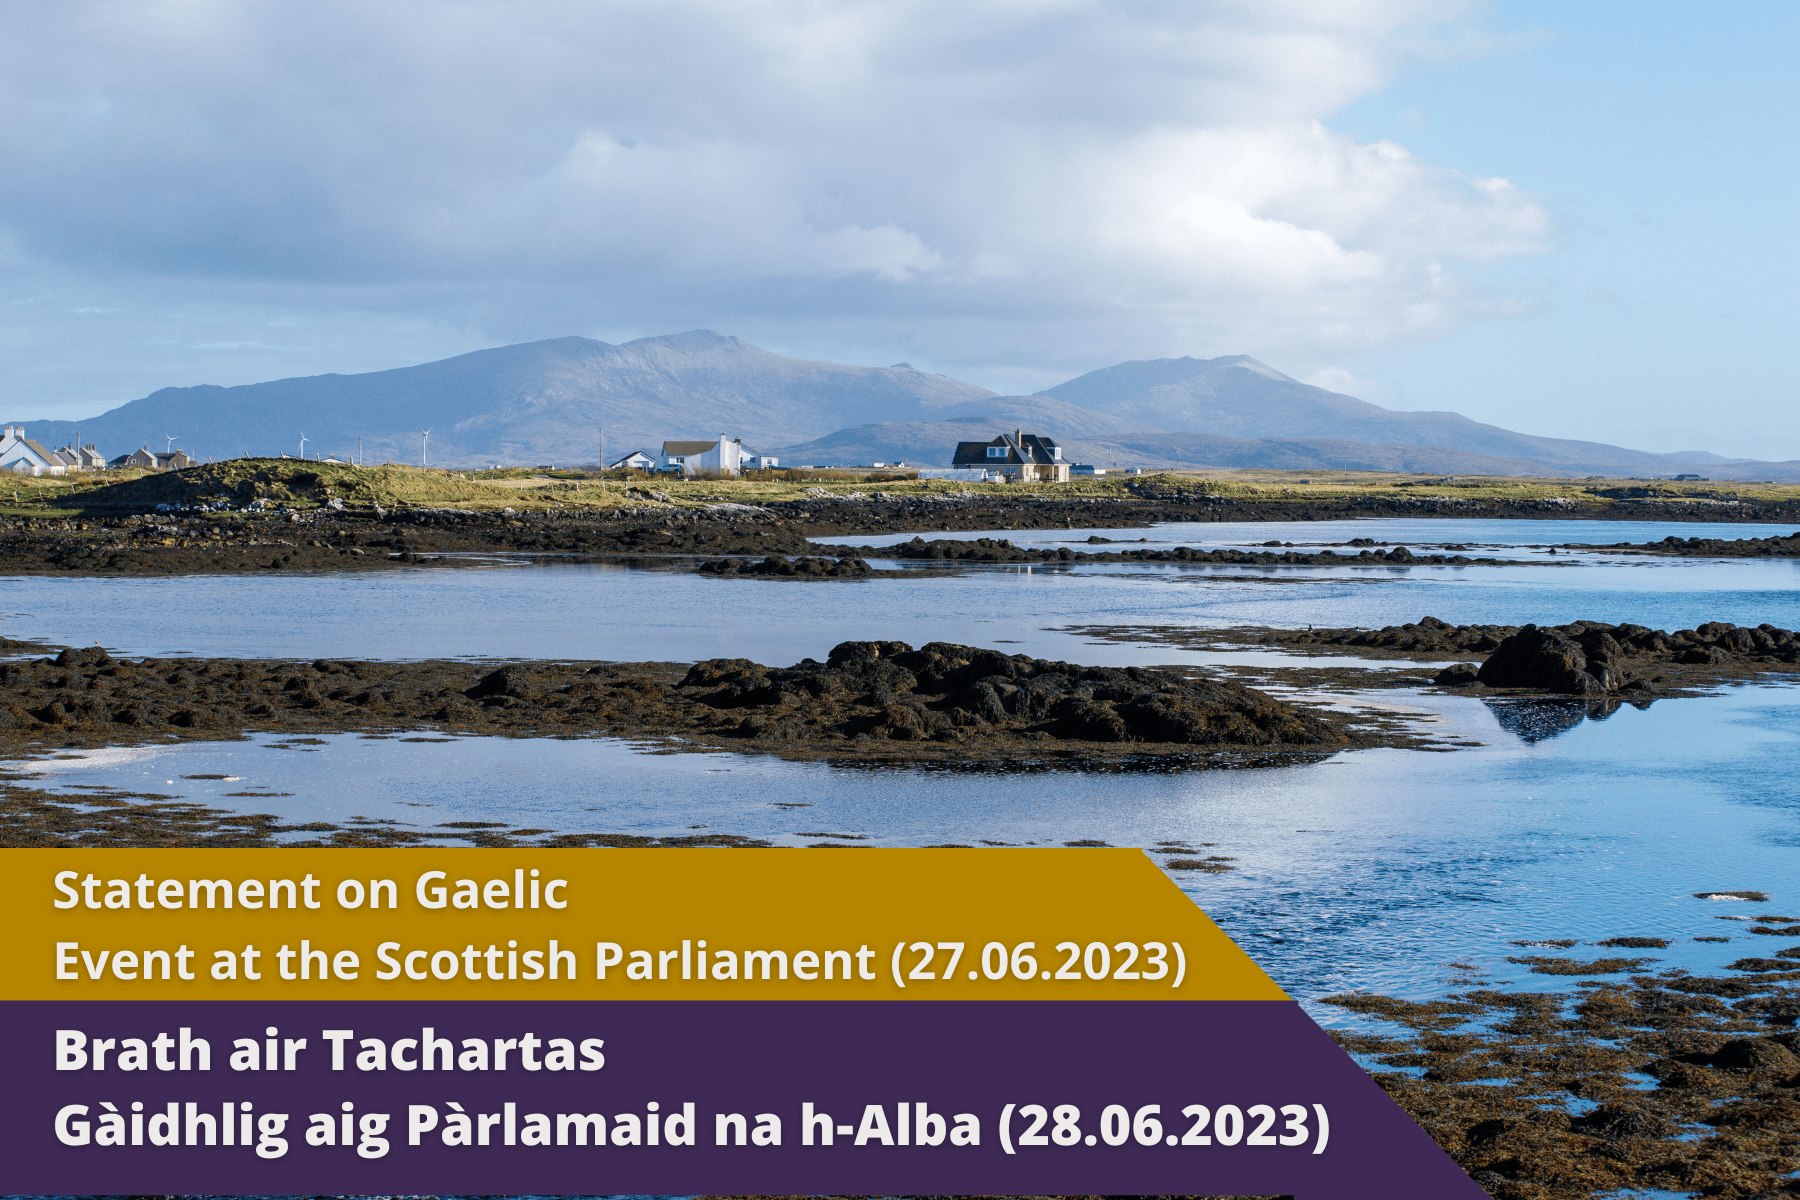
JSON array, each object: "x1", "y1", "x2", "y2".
[{"x1": 0, "y1": 459, "x2": 1800, "y2": 516}]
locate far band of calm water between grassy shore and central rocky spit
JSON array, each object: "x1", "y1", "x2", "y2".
[{"x1": 0, "y1": 522, "x2": 1800, "y2": 664}]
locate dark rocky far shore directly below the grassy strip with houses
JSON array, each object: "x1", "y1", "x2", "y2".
[{"x1": 0, "y1": 488, "x2": 1793, "y2": 578}]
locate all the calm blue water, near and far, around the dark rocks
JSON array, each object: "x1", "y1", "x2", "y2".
[{"x1": 0, "y1": 522, "x2": 1800, "y2": 1022}]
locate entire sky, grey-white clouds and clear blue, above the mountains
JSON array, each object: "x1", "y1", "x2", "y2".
[{"x1": 0, "y1": 0, "x2": 1800, "y2": 459}]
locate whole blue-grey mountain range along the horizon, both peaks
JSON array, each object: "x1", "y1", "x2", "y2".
[{"x1": 13, "y1": 329, "x2": 1800, "y2": 479}]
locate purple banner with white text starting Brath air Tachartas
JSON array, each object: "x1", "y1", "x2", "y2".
[{"x1": 0, "y1": 1000, "x2": 1483, "y2": 1200}]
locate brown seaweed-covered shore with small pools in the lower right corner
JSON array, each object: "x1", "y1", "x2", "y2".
[{"x1": 1325, "y1": 910, "x2": 1800, "y2": 1200}]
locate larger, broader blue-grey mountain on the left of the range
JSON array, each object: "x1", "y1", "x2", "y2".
[{"x1": 7, "y1": 329, "x2": 1000, "y2": 466}]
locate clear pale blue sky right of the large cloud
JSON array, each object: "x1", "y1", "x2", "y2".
[{"x1": 1330, "y1": 4, "x2": 1800, "y2": 459}]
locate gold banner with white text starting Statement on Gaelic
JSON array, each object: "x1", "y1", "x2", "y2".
[{"x1": 0, "y1": 849, "x2": 1285, "y2": 1000}]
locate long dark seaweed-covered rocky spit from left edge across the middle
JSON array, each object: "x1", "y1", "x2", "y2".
[{"x1": 0, "y1": 642, "x2": 1354, "y2": 761}]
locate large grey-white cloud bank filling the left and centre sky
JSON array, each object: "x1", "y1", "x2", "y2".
[{"x1": 0, "y1": 0, "x2": 1552, "y2": 408}]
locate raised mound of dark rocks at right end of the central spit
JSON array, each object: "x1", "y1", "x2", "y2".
[{"x1": 680, "y1": 642, "x2": 1345, "y2": 747}]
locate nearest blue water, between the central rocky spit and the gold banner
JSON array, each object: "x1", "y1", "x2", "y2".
[{"x1": 17, "y1": 687, "x2": 1800, "y2": 1022}]
